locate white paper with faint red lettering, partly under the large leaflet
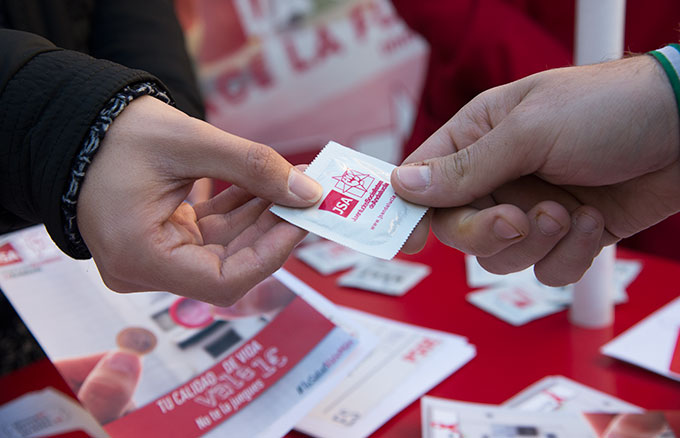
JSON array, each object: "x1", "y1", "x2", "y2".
[{"x1": 296, "y1": 308, "x2": 475, "y2": 438}]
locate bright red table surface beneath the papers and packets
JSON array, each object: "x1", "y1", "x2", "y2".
[{"x1": 0, "y1": 234, "x2": 680, "y2": 438}]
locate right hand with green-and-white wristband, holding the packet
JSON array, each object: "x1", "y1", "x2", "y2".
[{"x1": 392, "y1": 56, "x2": 680, "y2": 286}]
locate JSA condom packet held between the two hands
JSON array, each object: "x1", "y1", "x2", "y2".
[{"x1": 271, "y1": 141, "x2": 427, "y2": 260}]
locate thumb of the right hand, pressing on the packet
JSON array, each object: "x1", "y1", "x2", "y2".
[{"x1": 392, "y1": 120, "x2": 534, "y2": 207}]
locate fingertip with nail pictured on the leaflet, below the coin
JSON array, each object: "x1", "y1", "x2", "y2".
[{"x1": 78, "y1": 351, "x2": 142, "y2": 424}]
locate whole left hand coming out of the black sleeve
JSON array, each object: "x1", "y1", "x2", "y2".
[{"x1": 77, "y1": 97, "x2": 322, "y2": 306}]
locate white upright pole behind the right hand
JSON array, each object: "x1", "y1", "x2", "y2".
[{"x1": 569, "y1": 0, "x2": 626, "y2": 328}]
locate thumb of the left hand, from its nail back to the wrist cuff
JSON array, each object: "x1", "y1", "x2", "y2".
[{"x1": 113, "y1": 96, "x2": 322, "y2": 207}]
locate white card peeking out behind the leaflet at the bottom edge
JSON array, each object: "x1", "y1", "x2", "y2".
[{"x1": 503, "y1": 376, "x2": 643, "y2": 413}]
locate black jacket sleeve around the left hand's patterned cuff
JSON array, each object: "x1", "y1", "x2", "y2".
[{"x1": 0, "y1": 29, "x2": 163, "y2": 251}]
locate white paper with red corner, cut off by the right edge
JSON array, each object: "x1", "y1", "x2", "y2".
[{"x1": 601, "y1": 297, "x2": 680, "y2": 381}]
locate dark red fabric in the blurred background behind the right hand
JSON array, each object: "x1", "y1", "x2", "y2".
[{"x1": 392, "y1": 0, "x2": 680, "y2": 259}]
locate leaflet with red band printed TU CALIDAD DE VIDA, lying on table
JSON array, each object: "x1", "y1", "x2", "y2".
[{"x1": 0, "y1": 227, "x2": 370, "y2": 438}]
